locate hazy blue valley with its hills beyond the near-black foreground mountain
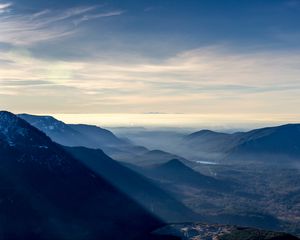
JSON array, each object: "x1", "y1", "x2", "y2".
[{"x1": 14, "y1": 111, "x2": 300, "y2": 237}]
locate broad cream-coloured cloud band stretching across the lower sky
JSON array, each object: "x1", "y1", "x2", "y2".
[{"x1": 0, "y1": 46, "x2": 300, "y2": 114}]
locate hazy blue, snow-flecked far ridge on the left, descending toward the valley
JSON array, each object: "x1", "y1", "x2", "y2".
[{"x1": 18, "y1": 114, "x2": 186, "y2": 164}]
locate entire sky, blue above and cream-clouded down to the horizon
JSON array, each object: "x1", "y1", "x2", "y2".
[{"x1": 0, "y1": 0, "x2": 300, "y2": 126}]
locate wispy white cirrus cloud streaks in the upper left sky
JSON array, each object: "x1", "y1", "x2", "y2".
[{"x1": 0, "y1": 3, "x2": 123, "y2": 45}]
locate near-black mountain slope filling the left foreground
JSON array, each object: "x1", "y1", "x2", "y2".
[{"x1": 0, "y1": 111, "x2": 163, "y2": 240}]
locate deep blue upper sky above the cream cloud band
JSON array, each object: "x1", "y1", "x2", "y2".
[{"x1": 3, "y1": 0, "x2": 300, "y2": 57}]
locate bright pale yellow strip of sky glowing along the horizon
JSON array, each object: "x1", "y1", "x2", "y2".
[{"x1": 48, "y1": 113, "x2": 300, "y2": 129}]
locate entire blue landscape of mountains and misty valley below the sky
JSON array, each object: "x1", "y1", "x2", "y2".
[{"x1": 0, "y1": 111, "x2": 300, "y2": 240}]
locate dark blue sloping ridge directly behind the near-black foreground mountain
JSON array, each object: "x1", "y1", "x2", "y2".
[{"x1": 65, "y1": 147, "x2": 201, "y2": 222}]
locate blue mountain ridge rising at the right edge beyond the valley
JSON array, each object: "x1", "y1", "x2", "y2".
[{"x1": 181, "y1": 124, "x2": 300, "y2": 163}]
